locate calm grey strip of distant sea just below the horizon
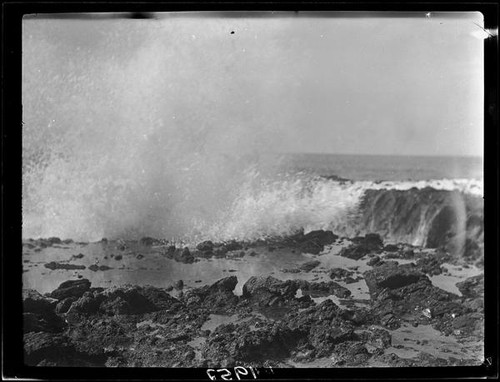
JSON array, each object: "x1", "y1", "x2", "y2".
[{"x1": 276, "y1": 154, "x2": 483, "y2": 181}]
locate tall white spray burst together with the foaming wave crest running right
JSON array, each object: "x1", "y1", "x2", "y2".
[{"x1": 22, "y1": 18, "x2": 482, "y2": 241}]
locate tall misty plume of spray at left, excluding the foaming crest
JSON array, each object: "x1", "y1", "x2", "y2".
[{"x1": 22, "y1": 20, "x2": 290, "y2": 240}]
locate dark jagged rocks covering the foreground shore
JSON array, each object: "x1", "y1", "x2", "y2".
[{"x1": 23, "y1": 231, "x2": 484, "y2": 367}]
